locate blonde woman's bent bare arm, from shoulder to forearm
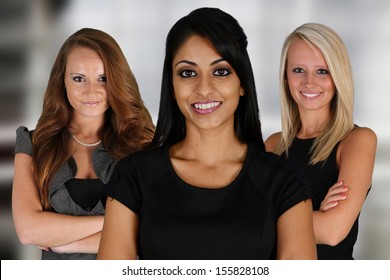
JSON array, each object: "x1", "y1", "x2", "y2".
[{"x1": 314, "y1": 128, "x2": 377, "y2": 246}]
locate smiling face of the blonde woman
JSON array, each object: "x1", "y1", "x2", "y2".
[{"x1": 286, "y1": 39, "x2": 336, "y2": 112}]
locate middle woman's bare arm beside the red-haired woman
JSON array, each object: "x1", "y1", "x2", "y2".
[{"x1": 97, "y1": 197, "x2": 139, "y2": 260}]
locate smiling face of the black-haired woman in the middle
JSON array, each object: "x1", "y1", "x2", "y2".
[{"x1": 172, "y1": 35, "x2": 244, "y2": 129}]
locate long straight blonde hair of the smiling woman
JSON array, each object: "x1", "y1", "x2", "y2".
[{"x1": 274, "y1": 23, "x2": 354, "y2": 164}]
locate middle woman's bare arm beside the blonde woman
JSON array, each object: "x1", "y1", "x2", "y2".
[{"x1": 277, "y1": 200, "x2": 317, "y2": 260}]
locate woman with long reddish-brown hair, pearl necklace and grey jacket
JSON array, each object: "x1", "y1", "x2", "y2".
[{"x1": 12, "y1": 28, "x2": 154, "y2": 259}]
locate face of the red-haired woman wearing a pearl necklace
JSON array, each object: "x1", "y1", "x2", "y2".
[{"x1": 64, "y1": 47, "x2": 109, "y2": 121}]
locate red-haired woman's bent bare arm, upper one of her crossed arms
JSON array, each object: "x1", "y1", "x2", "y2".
[{"x1": 12, "y1": 153, "x2": 104, "y2": 247}]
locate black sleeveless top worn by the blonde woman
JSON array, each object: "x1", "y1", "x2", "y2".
[{"x1": 283, "y1": 138, "x2": 359, "y2": 260}]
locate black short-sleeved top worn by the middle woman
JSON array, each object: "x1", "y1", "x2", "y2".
[{"x1": 107, "y1": 144, "x2": 309, "y2": 259}]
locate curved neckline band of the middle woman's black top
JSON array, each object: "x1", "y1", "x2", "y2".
[{"x1": 164, "y1": 143, "x2": 253, "y2": 193}]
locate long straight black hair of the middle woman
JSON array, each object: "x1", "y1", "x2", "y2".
[{"x1": 151, "y1": 8, "x2": 264, "y2": 149}]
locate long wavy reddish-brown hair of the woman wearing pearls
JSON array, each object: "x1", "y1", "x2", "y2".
[{"x1": 32, "y1": 28, "x2": 154, "y2": 209}]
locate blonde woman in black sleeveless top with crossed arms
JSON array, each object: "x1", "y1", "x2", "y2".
[{"x1": 265, "y1": 23, "x2": 377, "y2": 259}]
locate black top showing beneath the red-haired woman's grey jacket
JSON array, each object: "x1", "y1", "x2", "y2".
[{"x1": 65, "y1": 178, "x2": 105, "y2": 211}]
